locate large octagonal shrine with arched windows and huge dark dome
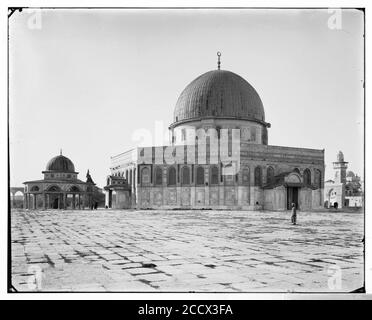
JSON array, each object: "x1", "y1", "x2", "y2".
[{"x1": 106, "y1": 57, "x2": 324, "y2": 210}]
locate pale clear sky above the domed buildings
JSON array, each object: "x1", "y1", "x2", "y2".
[{"x1": 9, "y1": 9, "x2": 364, "y2": 187}]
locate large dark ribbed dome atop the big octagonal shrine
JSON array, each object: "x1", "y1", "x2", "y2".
[{"x1": 172, "y1": 70, "x2": 265, "y2": 126}]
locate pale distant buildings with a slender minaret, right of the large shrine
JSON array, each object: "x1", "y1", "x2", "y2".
[{"x1": 324, "y1": 151, "x2": 363, "y2": 208}]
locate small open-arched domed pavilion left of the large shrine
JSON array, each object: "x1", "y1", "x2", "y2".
[{"x1": 23, "y1": 151, "x2": 95, "y2": 209}]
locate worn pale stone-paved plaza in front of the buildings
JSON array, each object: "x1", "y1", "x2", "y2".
[{"x1": 11, "y1": 210, "x2": 364, "y2": 292}]
